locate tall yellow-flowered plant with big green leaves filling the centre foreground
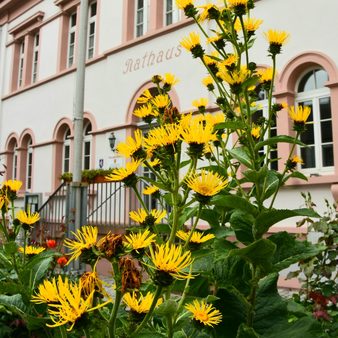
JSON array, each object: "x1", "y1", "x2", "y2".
[{"x1": 0, "y1": 0, "x2": 332, "y2": 338}]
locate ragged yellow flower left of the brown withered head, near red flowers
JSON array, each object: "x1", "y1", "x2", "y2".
[{"x1": 63, "y1": 225, "x2": 98, "y2": 264}]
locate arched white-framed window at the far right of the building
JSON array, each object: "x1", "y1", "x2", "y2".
[{"x1": 295, "y1": 68, "x2": 334, "y2": 173}]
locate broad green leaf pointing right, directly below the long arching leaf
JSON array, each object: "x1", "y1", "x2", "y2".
[{"x1": 269, "y1": 231, "x2": 325, "y2": 271}]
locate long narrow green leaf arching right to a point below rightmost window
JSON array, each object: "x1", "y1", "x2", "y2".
[{"x1": 256, "y1": 208, "x2": 320, "y2": 237}]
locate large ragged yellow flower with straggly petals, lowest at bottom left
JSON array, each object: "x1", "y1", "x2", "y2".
[{"x1": 47, "y1": 281, "x2": 110, "y2": 331}]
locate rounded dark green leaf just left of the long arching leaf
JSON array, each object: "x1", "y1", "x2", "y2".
[{"x1": 230, "y1": 210, "x2": 255, "y2": 244}]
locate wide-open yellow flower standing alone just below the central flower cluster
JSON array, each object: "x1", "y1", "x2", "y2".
[{"x1": 186, "y1": 170, "x2": 228, "y2": 197}]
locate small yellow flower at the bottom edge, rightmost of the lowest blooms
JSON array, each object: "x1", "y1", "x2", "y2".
[{"x1": 185, "y1": 299, "x2": 222, "y2": 326}]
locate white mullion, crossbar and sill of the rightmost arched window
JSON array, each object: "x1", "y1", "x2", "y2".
[{"x1": 295, "y1": 86, "x2": 334, "y2": 175}]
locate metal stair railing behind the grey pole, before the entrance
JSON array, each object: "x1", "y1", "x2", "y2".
[{"x1": 32, "y1": 182, "x2": 139, "y2": 243}]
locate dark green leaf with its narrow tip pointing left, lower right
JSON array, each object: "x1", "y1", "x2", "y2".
[{"x1": 229, "y1": 239, "x2": 276, "y2": 272}]
